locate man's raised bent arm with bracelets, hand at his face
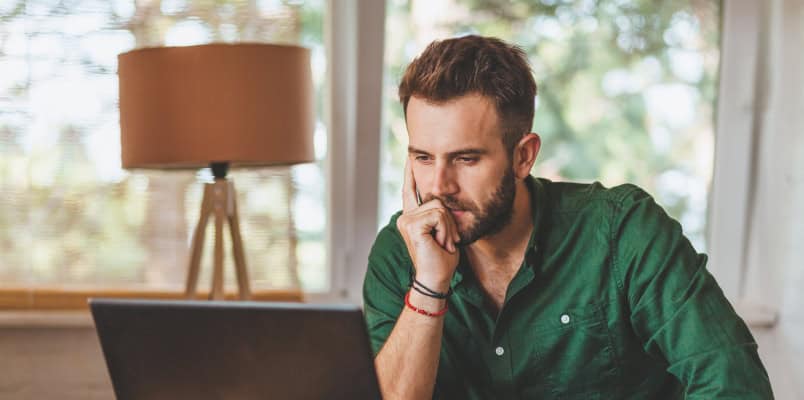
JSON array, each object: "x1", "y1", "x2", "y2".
[{"x1": 364, "y1": 161, "x2": 459, "y2": 399}]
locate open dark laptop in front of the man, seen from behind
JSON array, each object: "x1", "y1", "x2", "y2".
[{"x1": 89, "y1": 299, "x2": 380, "y2": 400}]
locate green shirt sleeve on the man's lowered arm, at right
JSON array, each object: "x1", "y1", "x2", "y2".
[{"x1": 612, "y1": 186, "x2": 773, "y2": 399}]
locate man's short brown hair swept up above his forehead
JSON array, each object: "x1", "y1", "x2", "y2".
[{"x1": 399, "y1": 35, "x2": 536, "y2": 155}]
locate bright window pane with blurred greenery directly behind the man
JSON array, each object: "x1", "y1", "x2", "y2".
[{"x1": 379, "y1": 0, "x2": 720, "y2": 251}]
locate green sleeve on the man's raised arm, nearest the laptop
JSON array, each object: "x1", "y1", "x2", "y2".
[{"x1": 363, "y1": 217, "x2": 412, "y2": 356}]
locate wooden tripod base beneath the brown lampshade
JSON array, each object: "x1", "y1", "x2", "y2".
[{"x1": 185, "y1": 163, "x2": 251, "y2": 300}]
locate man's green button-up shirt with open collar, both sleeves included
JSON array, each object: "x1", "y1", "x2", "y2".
[{"x1": 363, "y1": 177, "x2": 773, "y2": 400}]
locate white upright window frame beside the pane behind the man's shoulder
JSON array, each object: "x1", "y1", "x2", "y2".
[{"x1": 707, "y1": 0, "x2": 766, "y2": 303}]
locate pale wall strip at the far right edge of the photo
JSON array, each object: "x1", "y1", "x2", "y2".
[{"x1": 734, "y1": 0, "x2": 804, "y2": 399}]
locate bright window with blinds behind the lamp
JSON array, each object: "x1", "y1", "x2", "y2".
[{"x1": 0, "y1": 0, "x2": 329, "y2": 291}]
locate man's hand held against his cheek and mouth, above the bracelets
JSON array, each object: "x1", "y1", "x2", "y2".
[{"x1": 396, "y1": 162, "x2": 460, "y2": 292}]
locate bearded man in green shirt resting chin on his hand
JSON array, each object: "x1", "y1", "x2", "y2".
[{"x1": 364, "y1": 36, "x2": 773, "y2": 399}]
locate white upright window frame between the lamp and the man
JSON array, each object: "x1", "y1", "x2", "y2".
[{"x1": 305, "y1": 0, "x2": 385, "y2": 305}]
